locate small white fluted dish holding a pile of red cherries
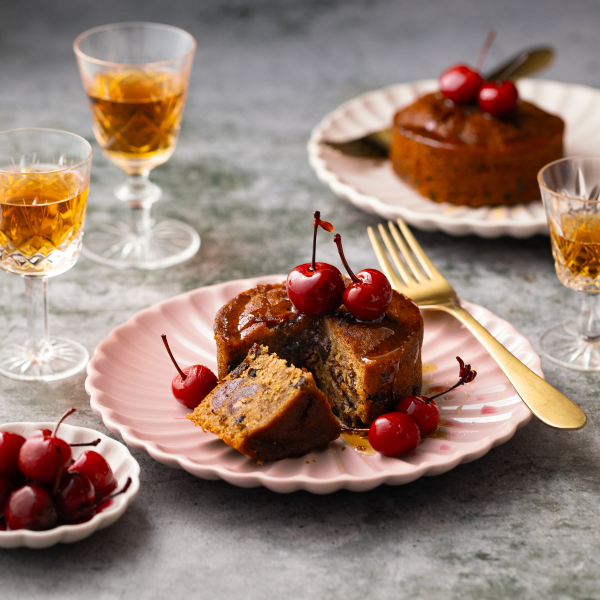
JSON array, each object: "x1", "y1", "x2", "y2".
[{"x1": 0, "y1": 422, "x2": 140, "y2": 549}]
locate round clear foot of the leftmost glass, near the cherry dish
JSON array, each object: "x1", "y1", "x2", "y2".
[{"x1": 0, "y1": 338, "x2": 90, "y2": 381}]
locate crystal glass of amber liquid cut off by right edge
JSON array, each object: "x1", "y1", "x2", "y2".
[{"x1": 538, "y1": 157, "x2": 600, "y2": 371}]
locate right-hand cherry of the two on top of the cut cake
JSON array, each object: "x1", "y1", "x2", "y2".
[{"x1": 333, "y1": 233, "x2": 392, "y2": 321}]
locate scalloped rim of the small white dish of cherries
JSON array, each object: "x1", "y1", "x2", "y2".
[{"x1": 0, "y1": 421, "x2": 141, "y2": 549}]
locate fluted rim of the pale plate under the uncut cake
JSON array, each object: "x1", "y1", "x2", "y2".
[{"x1": 307, "y1": 78, "x2": 600, "y2": 238}]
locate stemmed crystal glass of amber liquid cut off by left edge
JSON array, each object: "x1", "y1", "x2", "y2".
[{"x1": 0, "y1": 129, "x2": 92, "y2": 381}]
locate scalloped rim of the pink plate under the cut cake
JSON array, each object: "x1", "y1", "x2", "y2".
[{"x1": 85, "y1": 275, "x2": 543, "y2": 494}]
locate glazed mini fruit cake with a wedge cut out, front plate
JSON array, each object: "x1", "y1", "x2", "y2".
[{"x1": 213, "y1": 283, "x2": 423, "y2": 427}]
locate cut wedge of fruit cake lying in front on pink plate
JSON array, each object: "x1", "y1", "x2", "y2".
[{"x1": 188, "y1": 344, "x2": 341, "y2": 461}]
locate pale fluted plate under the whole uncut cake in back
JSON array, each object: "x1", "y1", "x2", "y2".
[{"x1": 308, "y1": 79, "x2": 600, "y2": 238}]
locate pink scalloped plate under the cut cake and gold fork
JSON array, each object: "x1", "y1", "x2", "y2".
[{"x1": 86, "y1": 275, "x2": 542, "y2": 494}]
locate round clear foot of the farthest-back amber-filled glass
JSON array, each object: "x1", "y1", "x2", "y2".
[{"x1": 82, "y1": 219, "x2": 200, "y2": 270}]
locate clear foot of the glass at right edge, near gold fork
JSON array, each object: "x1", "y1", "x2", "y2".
[{"x1": 540, "y1": 321, "x2": 600, "y2": 371}]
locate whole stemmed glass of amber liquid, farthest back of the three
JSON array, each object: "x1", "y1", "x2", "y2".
[{"x1": 73, "y1": 23, "x2": 200, "y2": 269}]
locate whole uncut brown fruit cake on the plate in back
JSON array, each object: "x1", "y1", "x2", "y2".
[{"x1": 390, "y1": 92, "x2": 564, "y2": 207}]
